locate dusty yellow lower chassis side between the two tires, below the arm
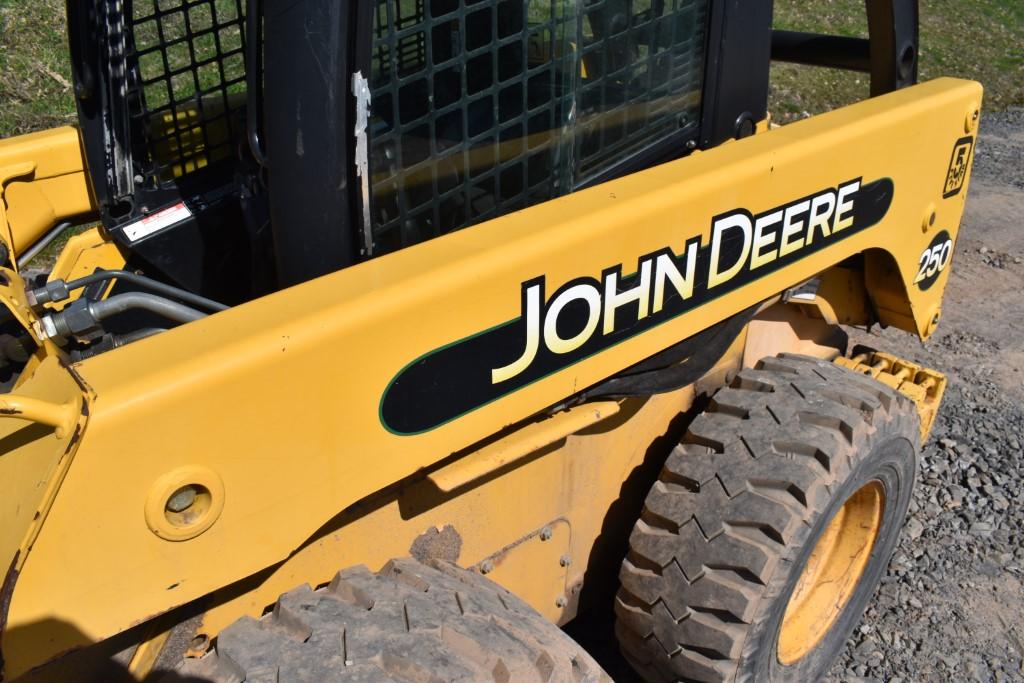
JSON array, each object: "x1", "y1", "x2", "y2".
[{"x1": 193, "y1": 387, "x2": 696, "y2": 636}]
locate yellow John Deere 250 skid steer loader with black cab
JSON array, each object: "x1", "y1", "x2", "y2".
[{"x1": 0, "y1": 0, "x2": 982, "y2": 681}]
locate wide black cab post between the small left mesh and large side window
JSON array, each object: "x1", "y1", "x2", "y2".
[{"x1": 263, "y1": 0, "x2": 356, "y2": 287}]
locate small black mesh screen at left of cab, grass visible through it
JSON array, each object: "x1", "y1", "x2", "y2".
[{"x1": 127, "y1": 0, "x2": 246, "y2": 187}]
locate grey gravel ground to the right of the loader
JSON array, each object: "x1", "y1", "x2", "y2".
[{"x1": 829, "y1": 111, "x2": 1024, "y2": 683}]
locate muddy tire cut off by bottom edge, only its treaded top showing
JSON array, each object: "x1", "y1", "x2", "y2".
[{"x1": 176, "y1": 559, "x2": 609, "y2": 683}]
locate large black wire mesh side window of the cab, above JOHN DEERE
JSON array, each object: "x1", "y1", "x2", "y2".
[{"x1": 369, "y1": 0, "x2": 708, "y2": 254}]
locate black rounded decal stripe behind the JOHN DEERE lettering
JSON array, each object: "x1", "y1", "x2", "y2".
[{"x1": 380, "y1": 178, "x2": 894, "y2": 435}]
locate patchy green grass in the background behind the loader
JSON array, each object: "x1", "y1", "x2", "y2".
[{"x1": 0, "y1": 0, "x2": 1024, "y2": 137}]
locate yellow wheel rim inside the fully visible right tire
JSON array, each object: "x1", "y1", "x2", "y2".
[{"x1": 778, "y1": 481, "x2": 886, "y2": 666}]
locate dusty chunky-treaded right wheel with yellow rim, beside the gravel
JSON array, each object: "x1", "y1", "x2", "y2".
[{"x1": 615, "y1": 354, "x2": 919, "y2": 681}]
